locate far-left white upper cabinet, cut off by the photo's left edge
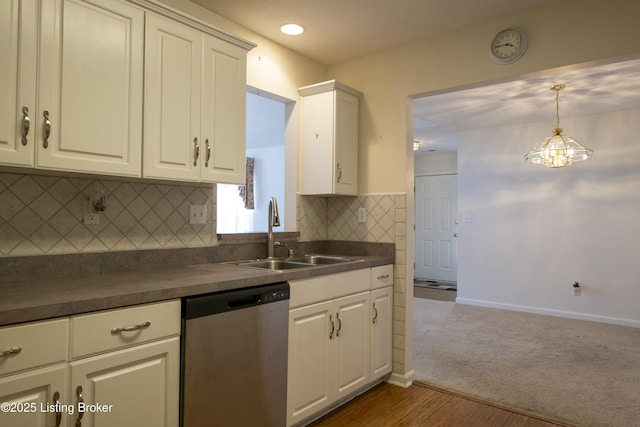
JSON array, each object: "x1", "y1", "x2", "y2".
[{"x1": 0, "y1": 0, "x2": 144, "y2": 176}]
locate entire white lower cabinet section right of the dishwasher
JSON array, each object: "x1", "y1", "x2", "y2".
[{"x1": 287, "y1": 266, "x2": 393, "y2": 426}]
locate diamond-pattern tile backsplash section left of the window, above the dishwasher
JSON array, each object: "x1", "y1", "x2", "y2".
[{"x1": 0, "y1": 173, "x2": 216, "y2": 256}]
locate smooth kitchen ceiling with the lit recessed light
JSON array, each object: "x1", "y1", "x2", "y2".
[{"x1": 191, "y1": 0, "x2": 564, "y2": 65}]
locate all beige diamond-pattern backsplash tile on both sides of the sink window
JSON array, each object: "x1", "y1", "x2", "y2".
[{"x1": 0, "y1": 172, "x2": 405, "y2": 257}]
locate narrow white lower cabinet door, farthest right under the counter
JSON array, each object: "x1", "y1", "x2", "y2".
[{"x1": 371, "y1": 286, "x2": 393, "y2": 380}]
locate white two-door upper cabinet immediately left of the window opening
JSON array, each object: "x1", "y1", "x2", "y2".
[{"x1": 144, "y1": 14, "x2": 246, "y2": 184}]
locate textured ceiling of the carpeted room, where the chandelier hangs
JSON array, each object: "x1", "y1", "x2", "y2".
[{"x1": 413, "y1": 60, "x2": 640, "y2": 152}]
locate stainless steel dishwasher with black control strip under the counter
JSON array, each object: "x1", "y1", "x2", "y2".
[{"x1": 180, "y1": 282, "x2": 289, "y2": 427}]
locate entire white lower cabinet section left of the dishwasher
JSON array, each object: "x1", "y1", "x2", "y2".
[{"x1": 0, "y1": 300, "x2": 180, "y2": 427}]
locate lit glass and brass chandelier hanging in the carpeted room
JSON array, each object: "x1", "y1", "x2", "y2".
[{"x1": 524, "y1": 84, "x2": 593, "y2": 168}]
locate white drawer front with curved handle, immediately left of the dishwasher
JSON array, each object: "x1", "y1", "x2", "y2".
[{"x1": 70, "y1": 300, "x2": 180, "y2": 359}]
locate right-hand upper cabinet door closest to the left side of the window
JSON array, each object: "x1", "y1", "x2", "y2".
[{"x1": 201, "y1": 36, "x2": 247, "y2": 184}]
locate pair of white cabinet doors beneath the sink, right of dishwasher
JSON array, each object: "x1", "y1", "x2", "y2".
[{"x1": 287, "y1": 292, "x2": 369, "y2": 425}]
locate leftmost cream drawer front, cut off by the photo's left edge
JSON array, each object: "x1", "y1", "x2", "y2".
[{"x1": 0, "y1": 319, "x2": 69, "y2": 376}]
